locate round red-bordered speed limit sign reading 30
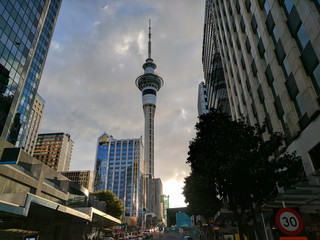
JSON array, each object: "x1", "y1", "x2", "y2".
[{"x1": 276, "y1": 208, "x2": 303, "y2": 236}]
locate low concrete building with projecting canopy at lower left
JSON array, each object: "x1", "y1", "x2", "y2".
[{"x1": 0, "y1": 137, "x2": 121, "y2": 240}]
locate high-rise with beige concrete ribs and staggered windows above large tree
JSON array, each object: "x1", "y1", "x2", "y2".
[{"x1": 207, "y1": 0, "x2": 320, "y2": 176}]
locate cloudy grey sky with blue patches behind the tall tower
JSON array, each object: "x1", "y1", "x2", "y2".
[{"x1": 38, "y1": 0, "x2": 205, "y2": 207}]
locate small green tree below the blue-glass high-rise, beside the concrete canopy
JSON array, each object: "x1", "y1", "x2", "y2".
[{"x1": 93, "y1": 191, "x2": 123, "y2": 219}]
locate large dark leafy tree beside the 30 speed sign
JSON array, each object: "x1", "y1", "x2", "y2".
[{"x1": 185, "y1": 109, "x2": 303, "y2": 238}]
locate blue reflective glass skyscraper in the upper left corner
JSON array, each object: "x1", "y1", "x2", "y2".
[{"x1": 0, "y1": 0, "x2": 62, "y2": 147}]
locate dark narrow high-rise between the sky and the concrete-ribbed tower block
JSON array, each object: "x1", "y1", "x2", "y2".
[{"x1": 199, "y1": 0, "x2": 230, "y2": 115}]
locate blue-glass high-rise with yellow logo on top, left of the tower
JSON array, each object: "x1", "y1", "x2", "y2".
[{"x1": 93, "y1": 133, "x2": 144, "y2": 217}]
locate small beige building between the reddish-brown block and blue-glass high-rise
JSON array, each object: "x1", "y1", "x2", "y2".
[{"x1": 60, "y1": 170, "x2": 93, "y2": 193}]
